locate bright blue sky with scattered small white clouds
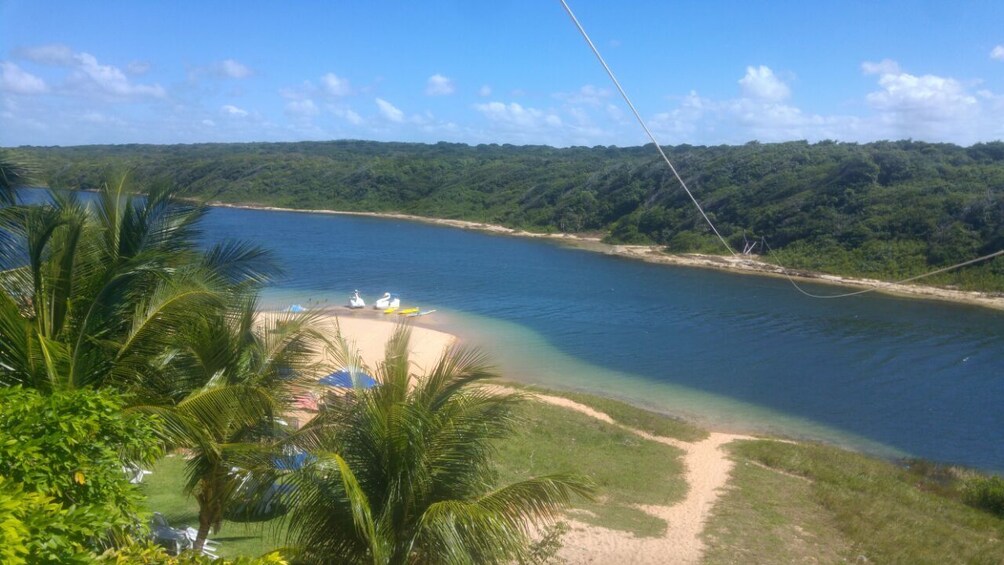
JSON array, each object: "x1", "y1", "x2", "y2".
[{"x1": 0, "y1": 0, "x2": 1004, "y2": 147}]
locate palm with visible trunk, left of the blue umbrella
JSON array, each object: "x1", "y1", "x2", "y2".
[{"x1": 143, "y1": 299, "x2": 320, "y2": 551}]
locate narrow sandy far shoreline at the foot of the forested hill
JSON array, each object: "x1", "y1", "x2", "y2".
[{"x1": 205, "y1": 201, "x2": 1004, "y2": 310}]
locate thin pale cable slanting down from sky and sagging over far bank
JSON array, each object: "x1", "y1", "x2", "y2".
[{"x1": 559, "y1": 0, "x2": 1004, "y2": 298}]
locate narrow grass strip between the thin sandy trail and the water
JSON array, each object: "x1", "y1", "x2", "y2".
[{"x1": 493, "y1": 382, "x2": 708, "y2": 442}]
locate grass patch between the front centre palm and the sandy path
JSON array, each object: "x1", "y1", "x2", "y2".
[{"x1": 498, "y1": 402, "x2": 687, "y2": 536}]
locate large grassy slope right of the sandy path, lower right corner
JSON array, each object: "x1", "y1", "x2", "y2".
[{"x1": 705, "y1": 441, "x2": 1004, "y2": 563}]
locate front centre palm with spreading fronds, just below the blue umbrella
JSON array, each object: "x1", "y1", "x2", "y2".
[{"x1": 286, "y1": 325, "x2": 591, "y2": 564}]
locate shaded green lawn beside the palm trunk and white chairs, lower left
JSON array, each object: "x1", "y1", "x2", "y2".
[{"x1": 141, "y1": 455, "x2": 285, "y2": 557}]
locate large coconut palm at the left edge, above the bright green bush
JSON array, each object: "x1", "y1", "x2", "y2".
[{"x1": 0, "y1": 180, "x2": 268, "y2": 395}]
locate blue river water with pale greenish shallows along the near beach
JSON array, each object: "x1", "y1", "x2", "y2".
[{"x1": 13, "y1": 192, "x2": 1004, "y2": 471}]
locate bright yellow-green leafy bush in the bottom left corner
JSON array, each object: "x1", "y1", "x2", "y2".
[{"x1": 0, "y1": 386, "x2": 160, "y2": 563}]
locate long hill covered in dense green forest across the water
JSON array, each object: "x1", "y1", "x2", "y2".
[{"x1": 17, "y1": 140, "x2": 1004, "y2": 290}]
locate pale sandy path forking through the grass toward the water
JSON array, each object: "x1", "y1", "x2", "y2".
[{"x1": 534, "y1": 394, "x2": 752, "y2": 565}]
